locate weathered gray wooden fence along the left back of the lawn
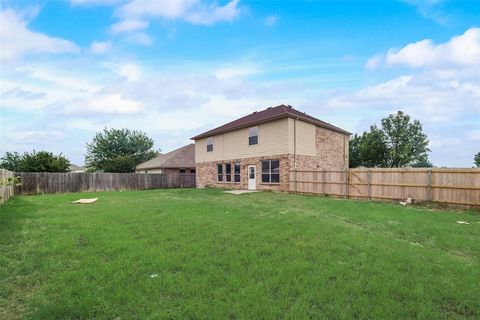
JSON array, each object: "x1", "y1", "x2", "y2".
[{"x1": 15, "y1": 172, "x2": 195, "y2": 195}]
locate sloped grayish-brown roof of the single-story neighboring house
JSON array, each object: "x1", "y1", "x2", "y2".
[{"x1": 136, "y1": 143, "x2": 195, "y2": 170}]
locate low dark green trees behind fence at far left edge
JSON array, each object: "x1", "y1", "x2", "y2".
[{"x1": 0, "y1": 150, "x2": 70, "y2": 172}]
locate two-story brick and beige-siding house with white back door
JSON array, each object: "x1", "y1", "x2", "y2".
[{"x1": 192, "y1": 105, "x2": 350, "y2": 191}]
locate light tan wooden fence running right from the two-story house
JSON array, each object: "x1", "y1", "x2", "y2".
[{"x1": 289, "y1": 168, "x2": 480, "y2": 206}]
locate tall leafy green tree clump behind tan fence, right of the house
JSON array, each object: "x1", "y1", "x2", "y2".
[{"x1": 350, "y1": 111, "x2": 431, "y2": 168}]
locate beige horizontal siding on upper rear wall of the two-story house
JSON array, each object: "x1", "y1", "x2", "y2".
[{"x1": 195, "y1": 118, "x2": 288, "y2": 163}]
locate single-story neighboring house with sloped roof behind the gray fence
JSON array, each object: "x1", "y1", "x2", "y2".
[{"x1": 135, "y1": 143, "x2": 195, "y2": 174}]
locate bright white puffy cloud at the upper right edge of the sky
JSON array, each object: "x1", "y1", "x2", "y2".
[{"x1": 367, "y1": 28, "x2": 480, "y2": 68}]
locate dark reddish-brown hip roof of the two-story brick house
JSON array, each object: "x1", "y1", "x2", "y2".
[{"x1": 192, "y1": 104, "x2": 350, "y2": 140}]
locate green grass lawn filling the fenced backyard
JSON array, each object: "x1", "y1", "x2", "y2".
[{"x1": 0, "y1": 189, "x2": 480, "y2": 319}]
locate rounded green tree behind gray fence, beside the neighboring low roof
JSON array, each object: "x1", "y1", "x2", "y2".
[{"x1": 85, "y1": 128, "x2": 158, "y2": 172}]
